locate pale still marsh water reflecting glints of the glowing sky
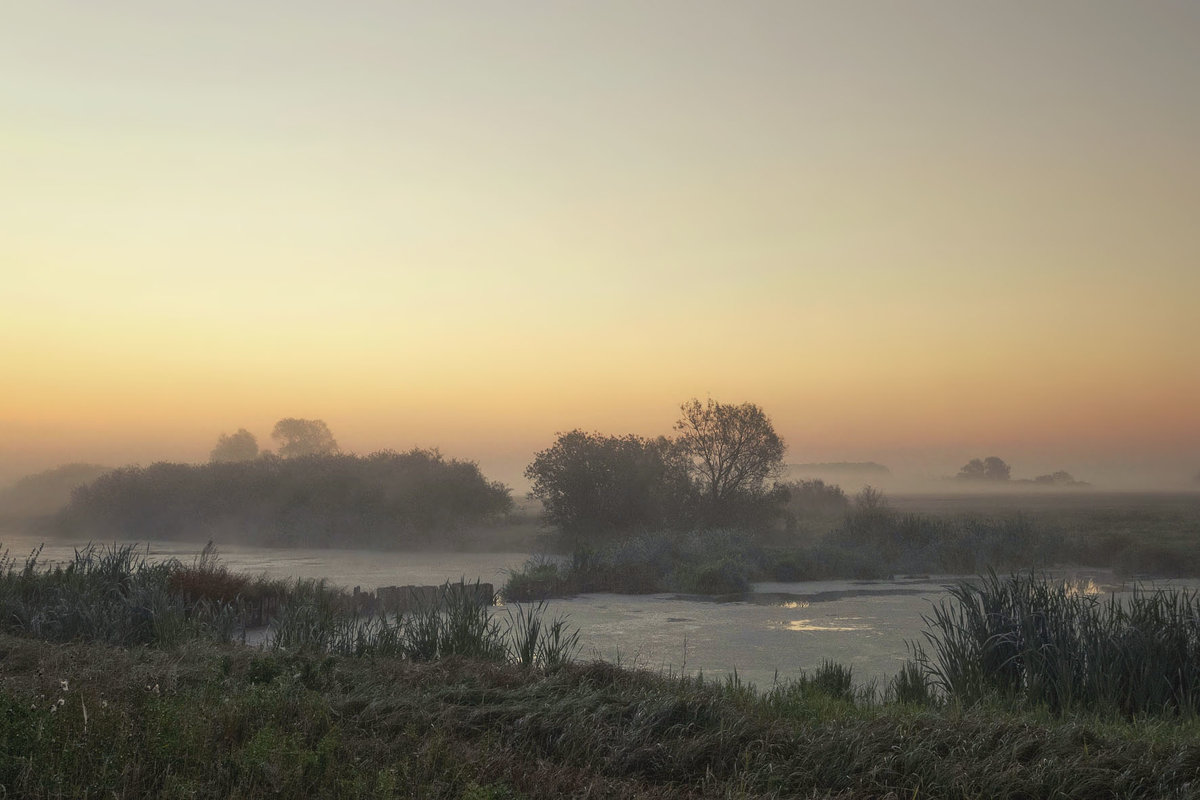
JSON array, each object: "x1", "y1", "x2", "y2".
[{"x1": 0, "y1": 534, "x2": 1171, "y2": 687}]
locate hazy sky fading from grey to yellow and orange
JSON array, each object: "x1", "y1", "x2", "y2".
[{"x1": 0, "y1": 0, "x2": 1200, "y2": 486}]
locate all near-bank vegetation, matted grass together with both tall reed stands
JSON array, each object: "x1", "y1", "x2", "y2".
[{"x1": 0, "y1": 548, "x2": 1200, "y2": 799}]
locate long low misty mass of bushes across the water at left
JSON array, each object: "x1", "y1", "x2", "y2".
[{"x1": 58, "y1": 450, "x2": 512, "y2": 547}]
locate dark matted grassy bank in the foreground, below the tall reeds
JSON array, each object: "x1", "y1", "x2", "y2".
[{"x1": 0, "y1": 637, "x2": 1200, "y2": 799}]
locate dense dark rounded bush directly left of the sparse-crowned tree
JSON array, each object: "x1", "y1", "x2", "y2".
[{"x1": 526, "y1": 431, "x2": 690, "y2": 535}]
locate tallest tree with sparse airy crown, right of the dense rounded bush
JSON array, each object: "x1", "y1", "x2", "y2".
[{"x1": 674, "y1": 398, "x2": 786, "y2": 521}]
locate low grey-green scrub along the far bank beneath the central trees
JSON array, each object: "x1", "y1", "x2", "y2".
[{"x1": 504, "y1": 487, "x2": 1066, "y2": 600}]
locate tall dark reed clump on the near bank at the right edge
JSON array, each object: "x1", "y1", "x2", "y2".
[{"x1": 919, "y1": 572, "x2": 1200, "y2": 716}]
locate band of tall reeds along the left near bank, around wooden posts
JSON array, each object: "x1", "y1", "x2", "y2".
[{"x1": 0, "y1": 545, "x2": 578, "y2": 668}]
